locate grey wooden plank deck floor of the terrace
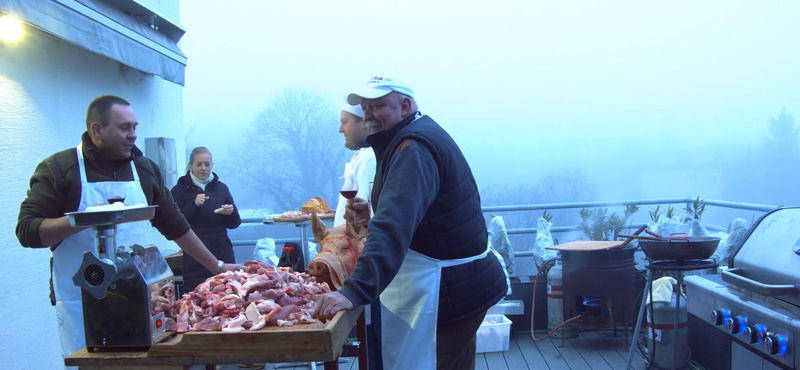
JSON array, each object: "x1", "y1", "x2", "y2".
[{"x1": 192, "y1": 331, "x2": 645, "y2": 370}]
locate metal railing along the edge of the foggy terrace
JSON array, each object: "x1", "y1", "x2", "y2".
[{"x1": 233, "y1": 198, "x2": 778, "y2": 257}]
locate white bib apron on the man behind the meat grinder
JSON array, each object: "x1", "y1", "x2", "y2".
[{"x1": 53, "y1": 143, "x2": 151, "y2": 357}]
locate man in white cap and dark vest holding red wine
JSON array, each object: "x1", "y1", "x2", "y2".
[{"x1": 315, "y1": 76, "x2": 506, "y2": 369}]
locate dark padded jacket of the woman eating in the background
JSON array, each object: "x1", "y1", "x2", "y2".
[{"x1": 172, "y1": 172, "x2": 242, "y2": 292}]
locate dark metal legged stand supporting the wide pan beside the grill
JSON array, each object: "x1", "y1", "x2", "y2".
[{"x1": 625, "y1": 259, "x2": 717, "y2": 370}]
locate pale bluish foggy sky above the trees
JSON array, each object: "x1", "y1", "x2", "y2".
[{"x1": 180, "y1": 0, "x2": 800, "y2": 207}]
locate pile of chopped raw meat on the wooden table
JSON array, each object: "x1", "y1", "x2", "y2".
[{"x1": 156, "y1": 261, "x2": 330, "y2": 333}]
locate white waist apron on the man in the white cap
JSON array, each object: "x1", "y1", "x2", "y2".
[{"x1": 381, "y1": 244, "x2": 489, "y2": 370}]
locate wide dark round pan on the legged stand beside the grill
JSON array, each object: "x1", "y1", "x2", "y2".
[{"x1": 639, "y1": 236, "x2": 720, "y2": 261}]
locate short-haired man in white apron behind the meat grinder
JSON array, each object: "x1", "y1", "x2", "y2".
[{"x1": 17, "y1": 95, "x2": 240, "y2": 368}]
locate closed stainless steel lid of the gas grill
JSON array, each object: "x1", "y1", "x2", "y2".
[{"x1": 722, "y1": 208, "x2": 800, "y2": 306}]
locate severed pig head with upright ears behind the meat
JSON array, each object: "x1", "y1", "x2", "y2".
[{"x1": 308, "y1": 213, "x2": 367, "y2": 291}]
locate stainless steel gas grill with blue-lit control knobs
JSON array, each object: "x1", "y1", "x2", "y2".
[{"x1": 685, "y1": 208, "x2": 800, "y2": 370}]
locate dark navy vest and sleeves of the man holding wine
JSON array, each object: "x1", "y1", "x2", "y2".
[{"x1": 339, "y1": 115, "x2": 507, "y2": 325}]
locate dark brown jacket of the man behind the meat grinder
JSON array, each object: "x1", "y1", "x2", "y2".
[{"x1": 16, "y1": 132, "x2": 189, "y2": 249}]
